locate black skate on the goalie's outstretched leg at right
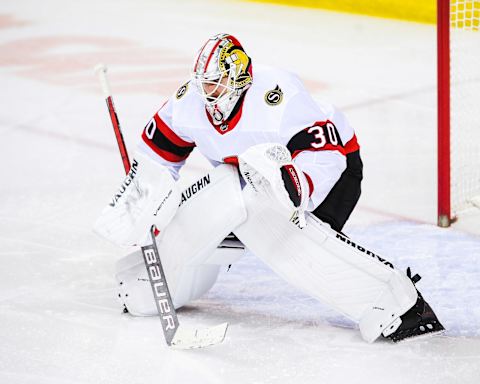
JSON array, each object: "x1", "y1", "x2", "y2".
[{"x1": 386, "y1": 268, "x2": 445, "y2": 342}]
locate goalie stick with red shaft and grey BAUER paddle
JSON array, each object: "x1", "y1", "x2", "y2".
[{"x1": 95, "y1": 64, "x2": 228, "y2": 349}]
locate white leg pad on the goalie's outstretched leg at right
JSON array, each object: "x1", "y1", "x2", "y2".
[{"x1": 234, "y1": 187, "x2": 417, "y2": 342}]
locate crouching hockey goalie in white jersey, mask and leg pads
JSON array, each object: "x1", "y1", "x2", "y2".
[{"x1": 95, "y1": 34, "x2": 443, "y2": 342}]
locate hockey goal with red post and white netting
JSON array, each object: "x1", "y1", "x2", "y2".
[{"x1": 437, "y1": 0, "x2": 480, "y2": 227}]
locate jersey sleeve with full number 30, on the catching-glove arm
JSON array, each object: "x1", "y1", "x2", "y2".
[{"x1": 282, "y1": 92, "x2": 358, "y2": 211}]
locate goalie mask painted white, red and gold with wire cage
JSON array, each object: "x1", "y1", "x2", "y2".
[{"x1": 192, "y1": 34, "x2": 252, "y2": 125}]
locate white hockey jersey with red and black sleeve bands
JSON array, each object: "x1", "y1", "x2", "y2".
[{"x1": 140, "y1": 67, "x2": 359, "y2": 210}]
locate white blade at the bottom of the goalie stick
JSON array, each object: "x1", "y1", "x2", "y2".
[{"x1": 170, "y1": 323, "x2": 228, "y2": 349}]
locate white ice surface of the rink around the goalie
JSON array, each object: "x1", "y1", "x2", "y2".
[{"x1": 0, "y1": 0, "x2": 480, "y2": 384}]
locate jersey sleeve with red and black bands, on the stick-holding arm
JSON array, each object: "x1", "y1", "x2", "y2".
[{"x1": 139, "y1": 100, "x2": 195, "y2": 180}]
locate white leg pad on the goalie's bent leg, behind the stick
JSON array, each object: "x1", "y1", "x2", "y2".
[{"x1": 117, "y1": 164, "x2": 246, "y2": 315}]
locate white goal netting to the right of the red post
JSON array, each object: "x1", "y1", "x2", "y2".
[{"x1": 450, "y1": 0, "x2": 480, "y2": 214}]
